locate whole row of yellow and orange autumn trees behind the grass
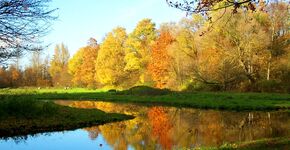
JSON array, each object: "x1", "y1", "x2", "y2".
[{"x1": 0, "y1": 2, "x2": 290, "y2": 92}]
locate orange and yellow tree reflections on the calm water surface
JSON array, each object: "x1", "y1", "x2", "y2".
[{"x1": 56, "y1": 101, "x2": 290, "y2": 149}]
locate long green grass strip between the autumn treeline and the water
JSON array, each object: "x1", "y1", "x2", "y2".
[{"x1": 0, "y1": 89, "x2": 290, "y2": 111}]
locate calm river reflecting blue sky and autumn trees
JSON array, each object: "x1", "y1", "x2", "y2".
[{"x1": 0, "y1": 101, "x2": 290, "y2": 150}]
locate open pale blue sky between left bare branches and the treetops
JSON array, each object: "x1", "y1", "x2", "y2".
[{"x1": 43, "y1": 0, "x2": 186, "y2": 55}]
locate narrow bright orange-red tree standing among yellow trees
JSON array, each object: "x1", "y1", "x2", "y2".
[{"x1": 148, "y1": 29, "x2": 174, "y2": 88}]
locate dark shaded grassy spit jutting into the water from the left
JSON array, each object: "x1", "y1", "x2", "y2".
[{"x1": 0, "y1": 96, "x2": 133, "y2": 138}]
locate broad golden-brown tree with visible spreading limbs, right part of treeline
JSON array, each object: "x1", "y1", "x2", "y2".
[{"x1": 191, "y1": 11, "x2": 270, "y2": 89}]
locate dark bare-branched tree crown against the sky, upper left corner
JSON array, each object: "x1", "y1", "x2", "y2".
[{"x1": 0, "y1": 0, "x2": 56, "y2": 63}]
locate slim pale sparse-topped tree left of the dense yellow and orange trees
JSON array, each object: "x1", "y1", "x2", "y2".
[{"x1": 49, "y1": 43, "x2": 71, "y2": 86}]
